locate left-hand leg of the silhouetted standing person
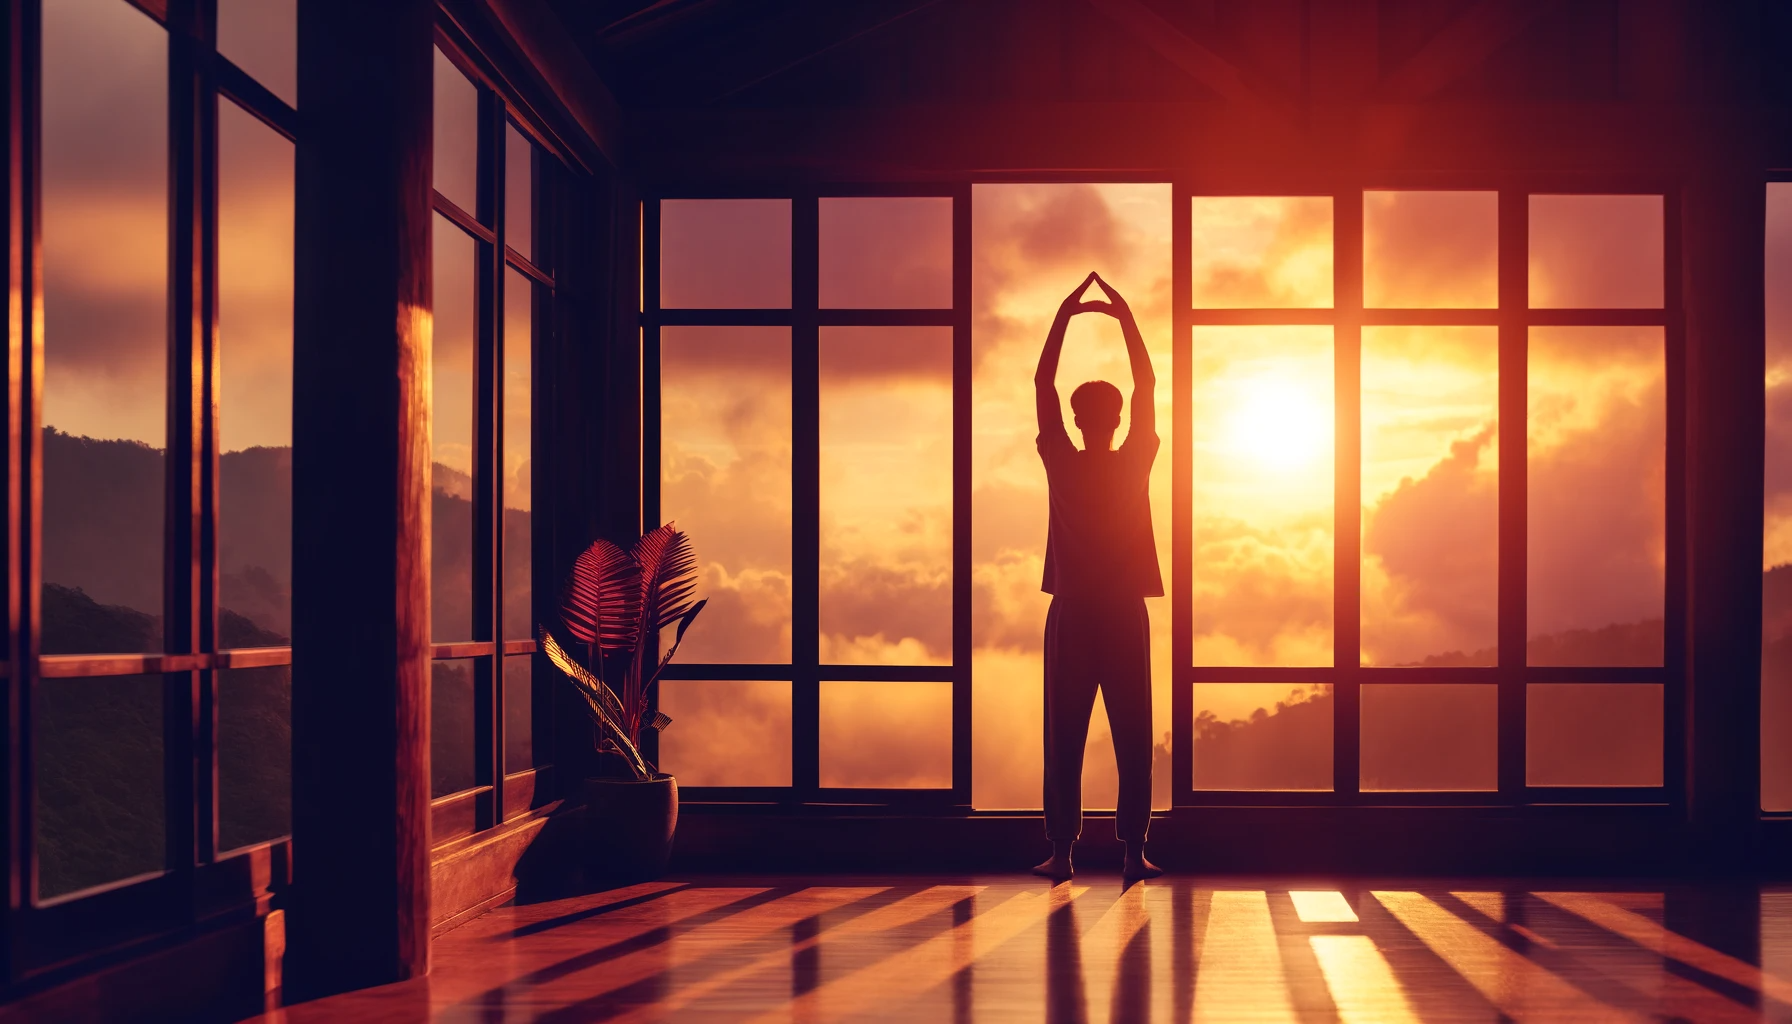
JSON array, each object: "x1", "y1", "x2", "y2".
[{"x1": 1034, "y1": 597, "x2": 1098, "y2": 879}]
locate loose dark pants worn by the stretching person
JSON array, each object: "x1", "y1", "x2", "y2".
[{"x1": 1045, "y1": 594, "x2": 1152, "y2": 843}]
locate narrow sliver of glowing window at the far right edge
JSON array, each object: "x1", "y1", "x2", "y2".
[{"x1": 1762, "y1": 181, "x2": 1792, "y2": 811}]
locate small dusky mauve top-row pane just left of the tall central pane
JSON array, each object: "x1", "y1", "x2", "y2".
[{"x1": 821, "y1": 195, "x2": 952, "y2": 308}]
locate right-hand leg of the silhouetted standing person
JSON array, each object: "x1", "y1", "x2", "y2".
[{"x1": 1102, "y1": 597, "x2": 1159, "y2": 879}]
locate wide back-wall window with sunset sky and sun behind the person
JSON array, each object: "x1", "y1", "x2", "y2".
[{"x1": 643, "y1": 185, "x2": 1683, "y2": 809}]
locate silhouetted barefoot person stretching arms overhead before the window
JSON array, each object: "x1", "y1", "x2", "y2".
[{"x1": 1032, "y1": 273, "x2": 1163, "y2": 881}]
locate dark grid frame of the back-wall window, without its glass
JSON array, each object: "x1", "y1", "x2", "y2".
[{"x1": 642, "y1": 172, "x2": 1688, "y2": 816}]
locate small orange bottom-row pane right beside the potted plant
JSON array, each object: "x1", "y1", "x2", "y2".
[{"x1": 659, "y1": 680, "x2": 790, "y2": 785}]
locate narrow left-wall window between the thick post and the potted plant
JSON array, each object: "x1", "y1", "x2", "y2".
[{"x1": 430, "y1": 47, "x2": 556, "y2": 843}]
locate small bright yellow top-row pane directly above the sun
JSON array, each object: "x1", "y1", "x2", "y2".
[{"x1": 1192, "y1": 195, "x2": 1331, "y2": 308}]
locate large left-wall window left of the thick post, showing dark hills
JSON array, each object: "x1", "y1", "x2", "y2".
[{"x1": 23, "y1": 0, "x2": 297, "y2": 946}]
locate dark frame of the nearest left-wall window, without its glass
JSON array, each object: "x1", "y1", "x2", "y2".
[{"x1": 4, "y1": 0, "x2": 299, "y2": 985}]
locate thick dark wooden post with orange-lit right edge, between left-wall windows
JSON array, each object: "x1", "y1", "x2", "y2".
[{"x1": 287, "y1": 0, "x2": 435, "y2": 999}]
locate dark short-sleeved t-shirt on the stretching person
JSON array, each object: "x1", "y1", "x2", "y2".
[{"x1": 1038, "y1": 425, "x2": 1163, "y2": 597}]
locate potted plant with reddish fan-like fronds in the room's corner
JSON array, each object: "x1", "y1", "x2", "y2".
[{"x1": 539, "y1": 524, "x2": 706, "y2": 881}]
